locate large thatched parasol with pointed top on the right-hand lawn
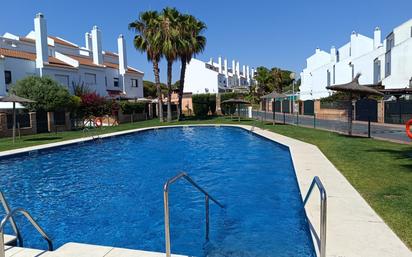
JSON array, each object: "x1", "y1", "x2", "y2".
[{"x1": 326, "y1": 73, "x2": 383, "y2": 135}]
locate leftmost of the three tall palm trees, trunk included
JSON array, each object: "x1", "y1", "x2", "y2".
[{"x1": 129, "y1": 11, "x2": 163, "y2": 122}]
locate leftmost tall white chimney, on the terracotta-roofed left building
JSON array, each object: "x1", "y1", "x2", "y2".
[{"x1": 34, "y1": 13, "x2": 49, "y2": 68}]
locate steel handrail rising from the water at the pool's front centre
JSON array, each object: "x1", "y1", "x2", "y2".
[{"x1": 163, "y1": 172, "x2": 224, "y2": 257}]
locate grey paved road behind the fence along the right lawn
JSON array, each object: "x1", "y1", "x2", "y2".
[{"x1": 253, "y1": 111, "x2": 412, "y2": 143}]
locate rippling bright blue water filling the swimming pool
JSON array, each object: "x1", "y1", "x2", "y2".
[{"x1": 0, "y1": 127, "x2": 315, "y2": 257}]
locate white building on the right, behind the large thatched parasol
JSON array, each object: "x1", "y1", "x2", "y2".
[{"x1": 300, "y1": 19, "x2": 412, "y2": 100}]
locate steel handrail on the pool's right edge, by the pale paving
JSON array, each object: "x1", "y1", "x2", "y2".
[{"x1": 303, "y1": 176, "x2": 327, "y2": 257}]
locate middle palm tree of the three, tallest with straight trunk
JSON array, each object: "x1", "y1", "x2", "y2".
[{"x1": 159, "y1": 7, "x2": 183, "y2": 122}]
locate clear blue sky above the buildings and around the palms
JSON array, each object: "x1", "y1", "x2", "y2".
[{"x1": 0, "y1": 0, "x2": 412, "y2": 81}]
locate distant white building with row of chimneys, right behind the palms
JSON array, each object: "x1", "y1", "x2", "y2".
[{"x1": 184, "y1": 57, "x2": 255, "y2": 94}]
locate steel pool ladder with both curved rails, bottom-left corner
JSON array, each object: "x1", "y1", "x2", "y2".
[{"x1": 0, "y1": 191, "x2": 53, "y2": 257}]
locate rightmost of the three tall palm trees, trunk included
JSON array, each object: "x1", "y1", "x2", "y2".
[{"x1": 178, "y1": 14, "x2": 206, "y2": 119}]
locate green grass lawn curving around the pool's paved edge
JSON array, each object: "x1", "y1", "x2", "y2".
[{"x1": 0, "y1": 118, "x2": 412, "y2": 246}]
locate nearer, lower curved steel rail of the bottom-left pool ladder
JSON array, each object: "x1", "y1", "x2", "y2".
[{"x1": 0, "y1": 208, "x2": 53, "y2": 257}]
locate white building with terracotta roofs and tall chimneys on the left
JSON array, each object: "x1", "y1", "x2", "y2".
[{"x1": 0, "y1": 14, "x2": 144, "y2": 98}]
